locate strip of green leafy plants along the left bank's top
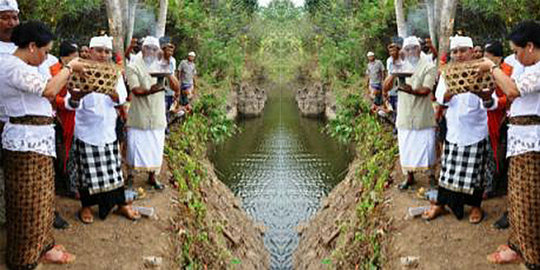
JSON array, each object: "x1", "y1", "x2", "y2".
[{"x1": 165, "y1": 89, "x2": 237, "y2": 269}]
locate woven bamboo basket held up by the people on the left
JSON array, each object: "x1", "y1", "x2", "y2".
[{"x1": 68, "y1": 59, "x2": 120, "y2": 95}]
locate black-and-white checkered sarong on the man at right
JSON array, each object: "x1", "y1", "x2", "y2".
[{"x1": 439, "y1": 139, "x2": 489, "y2": 195}]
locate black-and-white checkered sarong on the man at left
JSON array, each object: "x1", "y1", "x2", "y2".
[{"x1": 73, "y1": 139, "x2": 124, "y2": 195}]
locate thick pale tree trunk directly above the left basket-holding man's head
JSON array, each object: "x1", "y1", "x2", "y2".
[{"x1": 105, "y1": 0, "x2": 128, "y2": 55}]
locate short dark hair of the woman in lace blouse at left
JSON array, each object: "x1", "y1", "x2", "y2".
[{"x1": 11, "y1": 21, "x2": 54, "y2": 49}]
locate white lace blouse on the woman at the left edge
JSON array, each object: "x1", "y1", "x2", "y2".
[{"x1": 0, "y1": 55, "x2": 56, "y2": 157}]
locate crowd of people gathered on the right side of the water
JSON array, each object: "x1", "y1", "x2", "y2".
[{"x1": 366, "y1": 21, "x2": 540, "y2": 269}]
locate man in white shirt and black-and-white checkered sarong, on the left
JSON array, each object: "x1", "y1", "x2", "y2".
[{"x1": 66, "y1": 36, "x2": 140, "y2": 224}]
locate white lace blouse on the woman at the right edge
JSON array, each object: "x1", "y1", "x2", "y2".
[{"x1": 507, "y1": 62, "x2": 540, "y2": 156}]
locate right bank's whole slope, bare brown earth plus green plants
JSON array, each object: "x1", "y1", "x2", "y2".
[{"x1": 295, "y1": 94, "x2": 398, "y2": 269}]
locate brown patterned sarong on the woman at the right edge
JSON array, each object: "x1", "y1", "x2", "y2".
[{"x1": 508, "y1": 152, "x2": 540, "y2": 269}]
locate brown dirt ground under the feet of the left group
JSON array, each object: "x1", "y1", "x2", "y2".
[{"x1": 0, "y1": 162, "x2": 177, "y2": 270}]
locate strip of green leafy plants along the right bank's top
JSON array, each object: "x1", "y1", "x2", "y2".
[{"x1": 326, "y1": 94, "x2": 398, "y2": 269}]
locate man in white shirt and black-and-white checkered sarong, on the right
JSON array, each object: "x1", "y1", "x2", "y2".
[{"x1": 424, "y1": 36, "x2": 497, "y2": 224}]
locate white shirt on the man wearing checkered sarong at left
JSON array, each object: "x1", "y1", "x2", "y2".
[{"x1": 65, "y1": 76, "x2": 127, "y2": 146}]
